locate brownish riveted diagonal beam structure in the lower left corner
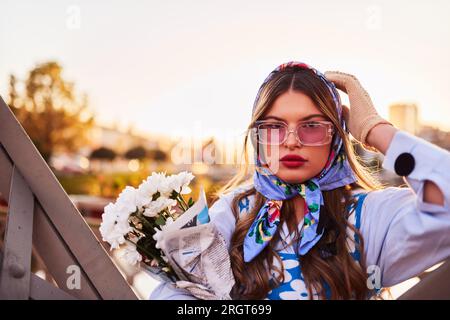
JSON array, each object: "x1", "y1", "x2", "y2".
[{"x1": 0, "y1": 97, "x2": 137, "y2": 299}]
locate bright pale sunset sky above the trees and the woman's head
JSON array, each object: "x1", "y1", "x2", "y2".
[{"x1": 0, "y1": 0, "x2": 450, "y2": 142}]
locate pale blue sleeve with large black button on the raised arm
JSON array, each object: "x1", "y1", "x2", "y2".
[{"x1": 360, "y1": 131, "x2": 450, "y2": 287}]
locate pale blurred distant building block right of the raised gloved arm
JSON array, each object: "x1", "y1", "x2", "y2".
[{"x1": 389, "y1": 103, "x2": 420, "y2": 134}]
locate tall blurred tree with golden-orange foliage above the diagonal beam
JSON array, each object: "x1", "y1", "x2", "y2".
[{"x1": 8, "y1": 62, "x2": 94, "y2": 162}]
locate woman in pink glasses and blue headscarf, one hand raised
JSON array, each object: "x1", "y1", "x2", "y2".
[{"x1": 150, "y1": 62, "x2": 450, "y2": 299}]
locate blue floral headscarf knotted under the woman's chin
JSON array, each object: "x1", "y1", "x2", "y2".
[{"x1": 244, "y1": 61, "x2": 356, "y2": 262}]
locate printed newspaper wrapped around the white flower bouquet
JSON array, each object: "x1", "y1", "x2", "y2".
[{"x1": 154, "y1": 189, "x2": 235, "y2": 300}]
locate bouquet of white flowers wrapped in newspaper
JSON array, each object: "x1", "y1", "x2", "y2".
[{"x1": 100, "y1": 171, "x2": 234, "y2": 299}]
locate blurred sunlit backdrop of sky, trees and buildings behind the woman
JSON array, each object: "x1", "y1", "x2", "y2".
[{"x1": 0, "y1": 0, "x2": 450, "y2": 299}]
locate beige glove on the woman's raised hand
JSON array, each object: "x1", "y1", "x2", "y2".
[{"x1": 324, "y1": 71, "x2": 392, "y2": 144}]
